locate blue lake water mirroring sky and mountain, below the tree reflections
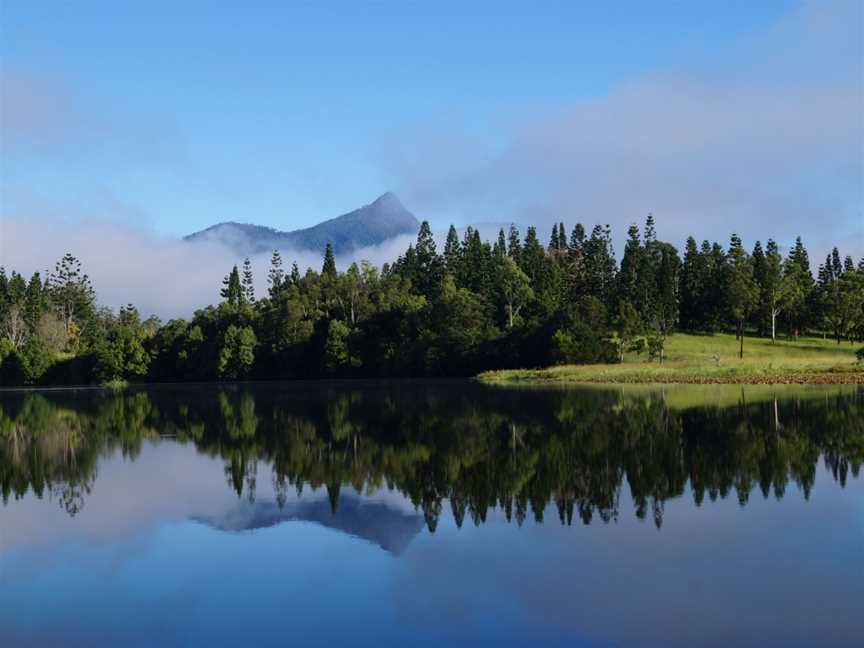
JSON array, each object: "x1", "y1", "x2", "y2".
[{"x1": 0, "y1": 388, "x2": 864, "y2": 646}]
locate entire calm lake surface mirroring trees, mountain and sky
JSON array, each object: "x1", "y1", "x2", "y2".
[{"x1": 0, "y1": 382, "x2": 864, "y2": 648}]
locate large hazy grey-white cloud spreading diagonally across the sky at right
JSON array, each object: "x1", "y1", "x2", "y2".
[{"x1": 384, "y1": 2, "x2": 864, "y2": 259}]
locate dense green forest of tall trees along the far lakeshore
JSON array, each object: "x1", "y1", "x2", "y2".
[{"x1": 0, "y1": 215, "x2": 864, "y2": 386}]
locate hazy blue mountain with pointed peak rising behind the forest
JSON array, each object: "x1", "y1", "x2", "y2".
[{"x1": 183, "y1": 192, "x2": 420, "y2": 256}]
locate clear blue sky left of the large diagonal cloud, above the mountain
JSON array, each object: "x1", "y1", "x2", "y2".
[{"x1": 0, "y1": 0, "x2": 852, "y2": 236}]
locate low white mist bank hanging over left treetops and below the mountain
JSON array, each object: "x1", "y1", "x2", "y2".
[{"x1": 0, "y1": 217, "x2": 414, "y2": 319}]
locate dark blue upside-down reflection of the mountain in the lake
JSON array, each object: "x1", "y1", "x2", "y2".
[{"x1": 192, "y1": 493, "x2": 424, "y2": 556}]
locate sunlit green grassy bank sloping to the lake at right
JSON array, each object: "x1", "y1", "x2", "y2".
[{"x1": 479, "y1": 333, "x2": 864, "y2": 384}]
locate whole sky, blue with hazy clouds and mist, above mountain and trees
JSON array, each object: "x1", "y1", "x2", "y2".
[{"x1": 0, "y1": 0, "x2": 864, "y2": 317}]
